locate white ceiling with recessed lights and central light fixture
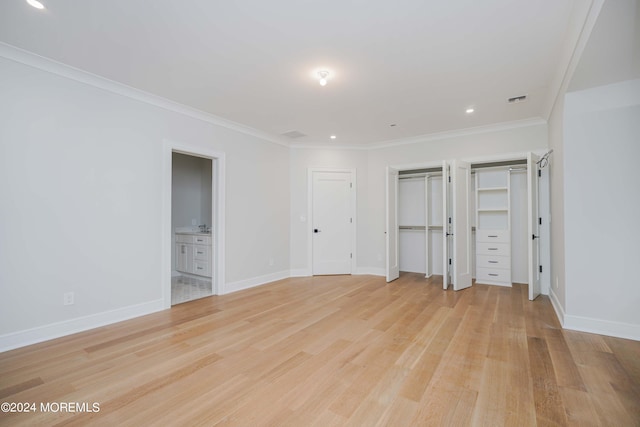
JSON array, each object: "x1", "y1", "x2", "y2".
[{"x1": 0, "y1": 0, "x2": 591, "y2": 146}]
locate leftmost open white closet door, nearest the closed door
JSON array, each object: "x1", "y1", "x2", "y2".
[{"x1": 385, "y1": 167, "x2": 400, "y2": 282}]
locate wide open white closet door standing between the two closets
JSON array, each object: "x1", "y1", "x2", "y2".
[{"x1": 451, "y1": 160, "x2": 472, "y2": 291}]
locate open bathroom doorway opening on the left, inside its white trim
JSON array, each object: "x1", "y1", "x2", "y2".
[{"x1": 171, "y1": 152, "x2": 213, "y2": 305}]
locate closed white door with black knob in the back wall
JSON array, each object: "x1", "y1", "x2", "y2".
[{"x1": 312, "y1": 171, "x2": 353, "y2": 275}]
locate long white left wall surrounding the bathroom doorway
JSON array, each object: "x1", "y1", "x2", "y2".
[{"x1": 0, "y1": 54, "x2": 290, "y2": 349}]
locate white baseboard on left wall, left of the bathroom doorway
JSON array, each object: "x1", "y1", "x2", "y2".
[{"x1": 0, "y1": 299, "x2": 164, "y2": 352}]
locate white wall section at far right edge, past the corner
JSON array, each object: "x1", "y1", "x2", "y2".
[{"x1": 564, "y1": 79, "x2": 640, "y2": 339}]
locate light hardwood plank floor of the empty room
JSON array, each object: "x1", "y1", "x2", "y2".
[{"x1": 0, "y1": 274, "x2": 640, "y2": 426}]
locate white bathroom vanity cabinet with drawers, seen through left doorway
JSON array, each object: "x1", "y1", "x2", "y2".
[{"x1": 175, "y1": 233, "x2": 211, "y2": 277}]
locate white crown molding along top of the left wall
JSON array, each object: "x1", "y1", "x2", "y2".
[{"x1": 0, "y1": 42, "x2": 289, "y2": 147}]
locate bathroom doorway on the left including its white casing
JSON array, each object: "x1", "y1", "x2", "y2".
[{"x1": 161, "y1": 140, "x2": 225, "y2": 308}]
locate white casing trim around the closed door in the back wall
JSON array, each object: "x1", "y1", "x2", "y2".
[{"x1": 307, "y1": 167, "x2": 358, "y2": 276}]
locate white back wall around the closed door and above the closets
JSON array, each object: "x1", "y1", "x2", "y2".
[{"x1": 290, "y1": 122, "x2": 547, "y2": 275}]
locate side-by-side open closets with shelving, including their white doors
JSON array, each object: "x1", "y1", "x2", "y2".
[{"x1": 386, "y1": 153, "x2": 550, "y2": 299}]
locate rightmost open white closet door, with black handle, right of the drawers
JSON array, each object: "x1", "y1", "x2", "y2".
[{"x1": 527, "y1": 153, "x2": 540, "y2": 301}]
